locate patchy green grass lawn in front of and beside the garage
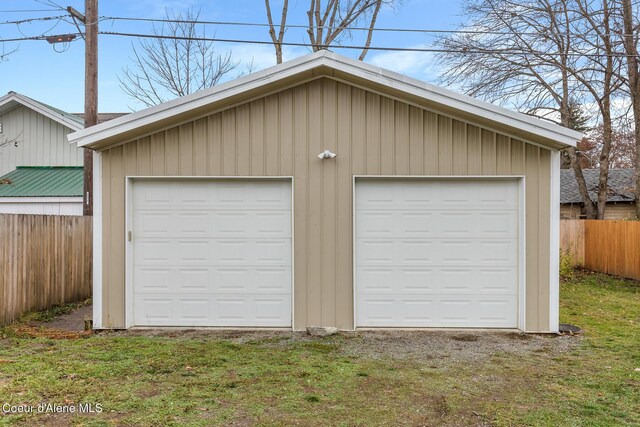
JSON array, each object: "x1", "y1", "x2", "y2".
[{"x1": 0, "y1": 273, "x2": 640, "y2": 426}]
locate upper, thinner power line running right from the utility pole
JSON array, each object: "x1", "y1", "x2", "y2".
[{"x1": 100, "y1": 16, "x2": 635, "y2": 37}]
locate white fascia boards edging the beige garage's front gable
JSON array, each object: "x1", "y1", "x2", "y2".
[{"x1": 68, "y1": 51, "x2": 582, "y2": 148}]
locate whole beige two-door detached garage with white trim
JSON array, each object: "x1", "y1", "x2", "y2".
[{"x1": 69, "y1": 51, "x2": 582, "y2": 332}]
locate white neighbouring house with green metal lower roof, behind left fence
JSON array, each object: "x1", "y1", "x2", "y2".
[{"x1": 0, "y1": 92, "x2": 124, "y2": 215}]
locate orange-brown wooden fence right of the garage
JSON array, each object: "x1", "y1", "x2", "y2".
[{"x1": 560, "y1": 220, "x2": 640, "y2": 280}]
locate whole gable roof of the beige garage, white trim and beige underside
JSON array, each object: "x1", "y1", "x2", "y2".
[{"x1": 68, "y1": 50, "x2": 582, "y2": 149}]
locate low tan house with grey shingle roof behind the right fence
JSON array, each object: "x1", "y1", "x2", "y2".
[{"x1": 560, "y1": 169, "x2": 636, "y2": 219}]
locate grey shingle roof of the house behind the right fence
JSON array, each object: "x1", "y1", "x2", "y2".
[{"x1": 560, "y1": 169, "x2": 636, "y2": 203}]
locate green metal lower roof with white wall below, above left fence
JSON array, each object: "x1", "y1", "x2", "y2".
[{"x1": 0, "y1": 166, "x2": 83, "y2": 215}]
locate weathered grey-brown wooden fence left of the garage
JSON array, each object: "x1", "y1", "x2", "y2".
[{"x1": 0, "y1": 215, "x2": 93, "y2": 324}]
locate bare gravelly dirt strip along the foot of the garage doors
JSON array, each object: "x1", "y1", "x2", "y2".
[{"x1": 106, "y1": 329, "x2": 580, "y2": 369}]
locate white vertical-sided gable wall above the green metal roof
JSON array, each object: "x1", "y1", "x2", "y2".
[{"x1": 0, "y1": 106, "x2": 82, "y2": 175}]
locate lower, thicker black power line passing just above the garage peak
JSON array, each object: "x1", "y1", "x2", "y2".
[{"x1": 95, "y1": 31, "x2": 640, "y2": 58}]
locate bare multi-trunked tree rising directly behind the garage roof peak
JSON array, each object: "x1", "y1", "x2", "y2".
[{"x1": 264, "y1": 0, "x2": 390, "y2": 64}]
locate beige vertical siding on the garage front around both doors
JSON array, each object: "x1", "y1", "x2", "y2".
[{"x1": 97, "y1": 78, "x2": 550, "y2": 331}]
